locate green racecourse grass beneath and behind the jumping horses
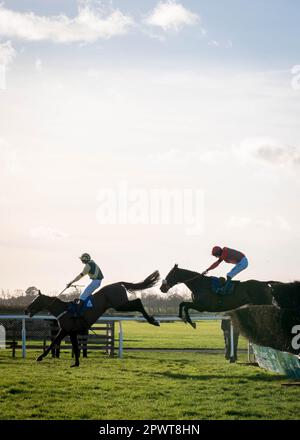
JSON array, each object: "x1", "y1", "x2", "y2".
[{"x1": 0, "y1": 323, "x2": 300, "y2": 420}]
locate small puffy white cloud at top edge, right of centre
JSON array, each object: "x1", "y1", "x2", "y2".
[{"x1": 145, "y1": 0, "x2": 199, "y2": 31}]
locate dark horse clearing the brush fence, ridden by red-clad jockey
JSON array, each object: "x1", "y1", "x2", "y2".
[{"x1": 160, "y1": 264, "x2": 275, "y2": 328}]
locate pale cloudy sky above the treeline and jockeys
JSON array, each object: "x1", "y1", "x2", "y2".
[{"x1": 0, "y1": 0, "x2": 300, "y2": 293}]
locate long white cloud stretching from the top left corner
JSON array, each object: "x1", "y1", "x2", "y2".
[{"x1": 0, "y1": 3, "x2": 133, "y2": 43}]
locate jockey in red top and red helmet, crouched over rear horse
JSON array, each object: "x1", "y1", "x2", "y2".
[{"x1": 202, "y1": 246, "x2": 248, "y2": 295}]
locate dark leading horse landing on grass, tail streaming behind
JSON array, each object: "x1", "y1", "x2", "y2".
[{"x1": 25, "y1": 271, "x2": 160, "y2": 367}]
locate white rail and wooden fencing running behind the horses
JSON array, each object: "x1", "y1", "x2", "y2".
[{"x1": 0, "y1": 314, "x2": 235, "y2": 359}]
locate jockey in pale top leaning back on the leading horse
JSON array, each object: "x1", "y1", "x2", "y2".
[{"x1": 67, "y1": 253, "x2": 103, "y2": 315}]
